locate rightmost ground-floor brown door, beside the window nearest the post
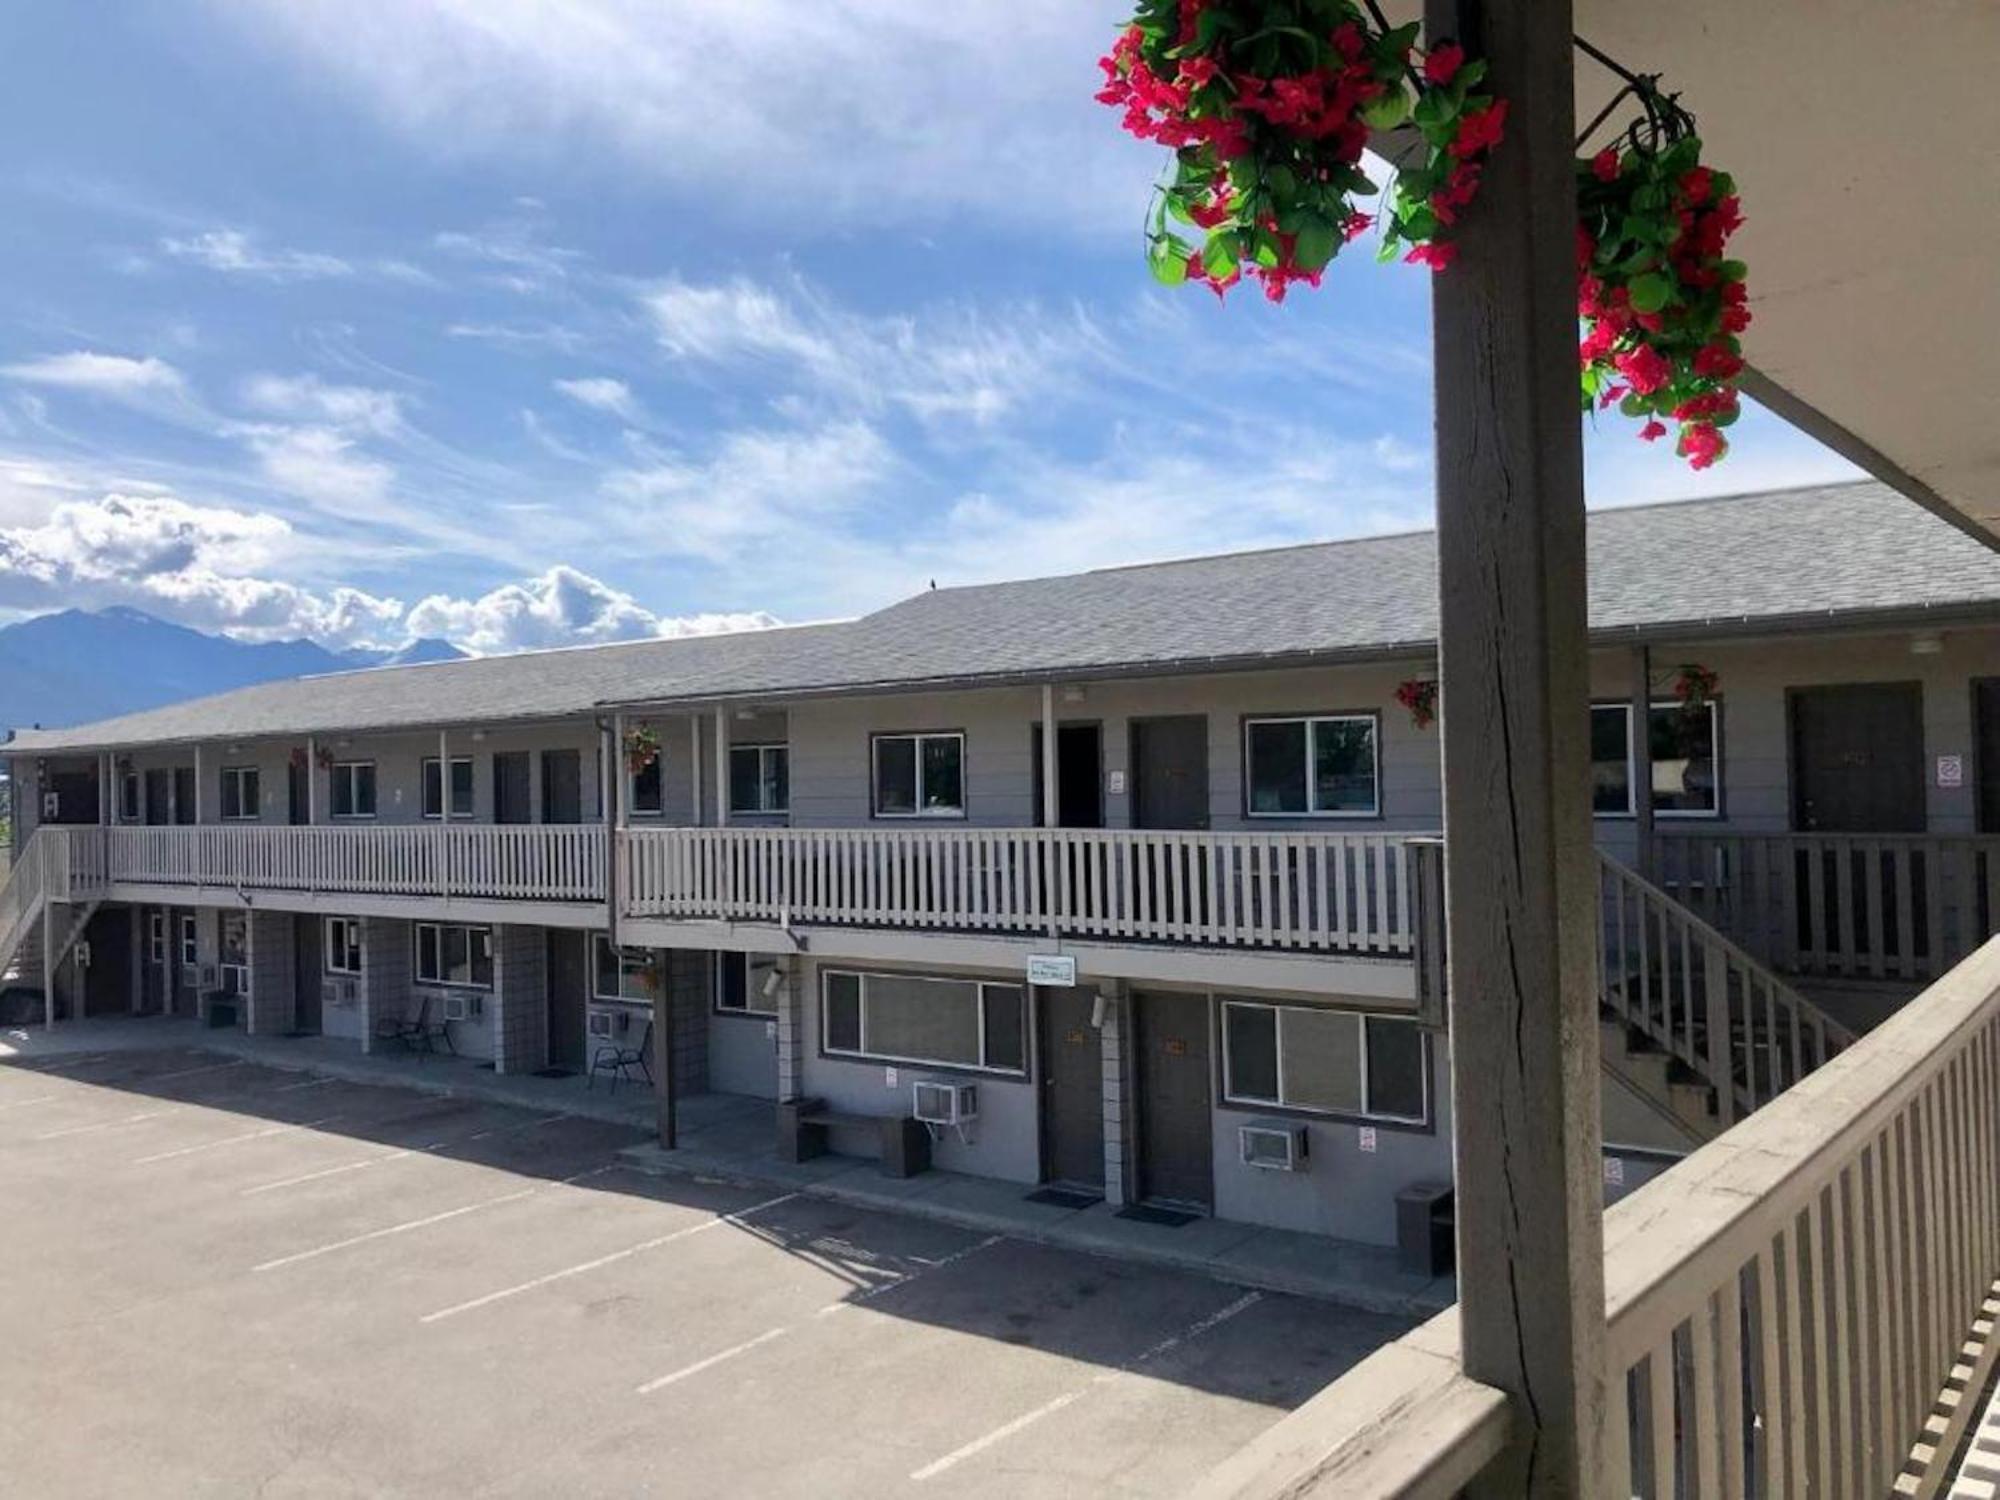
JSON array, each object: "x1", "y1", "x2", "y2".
[{"x1": 1132, "y1": 994, "x2": 1214, "y2": 1210}]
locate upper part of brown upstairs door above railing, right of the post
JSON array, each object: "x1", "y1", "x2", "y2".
[{"x1": 1790, "y1": 682, "x2": 1924, "y2": 834}]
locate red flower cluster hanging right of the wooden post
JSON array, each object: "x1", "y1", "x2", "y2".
[{"x1": 1576, "y1": 134, "x2": 1750, "y2": 468}]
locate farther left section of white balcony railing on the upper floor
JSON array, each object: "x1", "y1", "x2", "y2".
[{"x1": 76, "y1": 824, "x2": 604, "y2": 902}]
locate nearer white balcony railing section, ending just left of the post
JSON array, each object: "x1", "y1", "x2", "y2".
[{"x1": 620, "y1": 828, "x2": 1414, "y2": 956}]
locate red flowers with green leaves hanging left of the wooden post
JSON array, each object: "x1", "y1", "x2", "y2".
[{"x1": 1098, "y1": 0, "x2": 1506, "y2": 302}]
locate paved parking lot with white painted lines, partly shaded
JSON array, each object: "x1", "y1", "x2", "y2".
[{"x1": 0, "y1": 1048, "x2": 1402, "y2": 1496}]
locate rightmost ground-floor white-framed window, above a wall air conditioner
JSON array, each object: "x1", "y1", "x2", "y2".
[{"x1": 1222, "y1": 1000, "x2": 1430, "y2": 1124}]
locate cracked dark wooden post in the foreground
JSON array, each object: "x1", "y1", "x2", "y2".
[{"x1": 1426, "y1": 0, "x2": 1606, "y2": 1500}]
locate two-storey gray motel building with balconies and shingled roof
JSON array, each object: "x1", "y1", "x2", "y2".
[{"x1": 0, "y1": 484, "x2": 2000, "y2": 1258}]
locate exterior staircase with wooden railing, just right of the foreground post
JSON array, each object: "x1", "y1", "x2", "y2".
[{"x1": 1598, "y1": 852, "x2": 1854, "y2": 1146}]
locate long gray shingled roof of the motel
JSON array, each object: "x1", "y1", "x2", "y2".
[{"x1": 14, "y1": 484, "x2": 2000, "y2": 750}]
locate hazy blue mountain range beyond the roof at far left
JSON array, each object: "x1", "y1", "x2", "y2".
[{"x1": 0, "y1": 608, "x2": 466, "y2": 732}]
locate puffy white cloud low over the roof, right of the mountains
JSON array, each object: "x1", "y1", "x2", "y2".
[{"x1": 406, "y1": 564, "x2": 778, "y2": 652}]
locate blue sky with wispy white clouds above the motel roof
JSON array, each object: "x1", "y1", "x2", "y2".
[{"x1": 0, "y1": 0, "x2": 1850, "y2": 650}]
